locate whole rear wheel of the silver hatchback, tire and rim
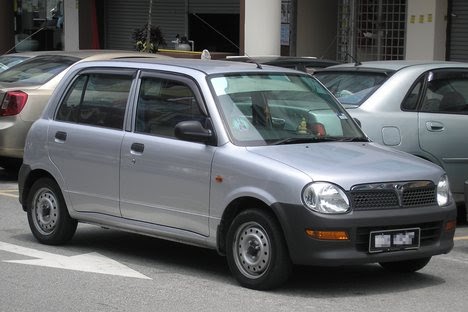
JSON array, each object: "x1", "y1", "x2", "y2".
[{"x1": 27, "y1": 178, "x2": 78, "y2": 245}]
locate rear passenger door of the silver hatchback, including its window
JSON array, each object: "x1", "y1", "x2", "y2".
[{"x1": 48, "y1": 69, "x2": 134, "y2": 216}]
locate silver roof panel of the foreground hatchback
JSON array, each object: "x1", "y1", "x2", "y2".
[{"x1": 73, "y1": 57, "x2": 299, "y2": 75}]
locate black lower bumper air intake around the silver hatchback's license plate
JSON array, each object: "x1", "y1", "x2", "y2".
[{"x1": 356, "y1": 222, "x2": 442, "y2": 252}]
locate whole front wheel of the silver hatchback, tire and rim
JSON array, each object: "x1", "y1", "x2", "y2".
[{"x1": 226, "y1": 209, "x2": 292, "y2": 290}]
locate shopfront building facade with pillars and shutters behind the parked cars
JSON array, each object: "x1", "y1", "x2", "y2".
[{"x1": 0, "y1": 0, "x2": 468, "y2": 61}]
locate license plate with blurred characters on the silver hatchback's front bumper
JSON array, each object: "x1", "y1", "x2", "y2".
[{"x1": 369, "y1": 228, "x2": 421, "y2": 253}]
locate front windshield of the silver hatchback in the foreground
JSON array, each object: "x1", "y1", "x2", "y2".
[{"x1": 210, "y1": 73, "x2": 366, "y2": 146}]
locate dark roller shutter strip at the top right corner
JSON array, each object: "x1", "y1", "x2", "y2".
[{"x1": 447, "y1": 0, "x2": 468, "y2": 62}]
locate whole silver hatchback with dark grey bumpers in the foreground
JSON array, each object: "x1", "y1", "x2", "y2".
[{"x1": 18, "y1": 59, "x2": 456, "y2": 289}]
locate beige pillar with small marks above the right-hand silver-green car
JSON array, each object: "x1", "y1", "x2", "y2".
[{"x1": 405, "y1": 0, "x2": 448, "y2": 60}]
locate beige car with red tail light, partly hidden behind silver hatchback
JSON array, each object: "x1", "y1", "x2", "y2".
[{"x1": 0, "y1": 50, "x2": 169, "y2": 171}]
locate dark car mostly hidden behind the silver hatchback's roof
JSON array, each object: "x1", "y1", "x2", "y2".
[{"x1": 226, "y1": 56, "x2": 339, "y2": 73}]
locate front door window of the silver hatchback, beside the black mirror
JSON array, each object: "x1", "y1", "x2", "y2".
[{"x1": 135, "y1": 77, "x2": 205, "y2": 137}]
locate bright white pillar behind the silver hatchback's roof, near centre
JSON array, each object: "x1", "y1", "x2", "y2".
[{"x1": 240, "y1": 0, "x2": 281, "y2": 56}]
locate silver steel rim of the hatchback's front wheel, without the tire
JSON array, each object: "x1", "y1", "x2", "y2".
[{"x1": 233, "y1": 222, "x2": 271, "y2": 278}]
